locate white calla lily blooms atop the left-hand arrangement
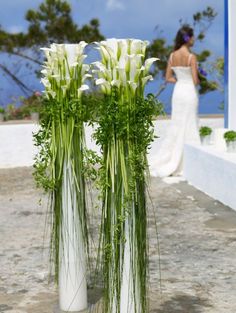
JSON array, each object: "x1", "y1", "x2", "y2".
[{"x1": 41, "y1": 41, "x2": 92, "y2": 101}]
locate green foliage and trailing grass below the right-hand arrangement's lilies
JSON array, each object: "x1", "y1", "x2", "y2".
[{"x1": 94, "y1": 87, "x2": 162, "y2": 312}]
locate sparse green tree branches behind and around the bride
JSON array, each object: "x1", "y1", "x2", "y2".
[{"x1": 148, "y1": 7, "x2": 220, "y2": 95}]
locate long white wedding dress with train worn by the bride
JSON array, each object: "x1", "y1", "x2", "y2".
[{"x1": 150, "y1": 54, "x2": 200, "y2": 177}]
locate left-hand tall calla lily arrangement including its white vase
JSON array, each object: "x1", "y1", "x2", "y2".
[{"x1": 34, "y1": 41, "x2": 91, "y2": 311}]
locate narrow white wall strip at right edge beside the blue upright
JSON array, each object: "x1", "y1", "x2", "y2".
[{"x1": 228, "y1": 0, "x2": 236, "y2": 130}]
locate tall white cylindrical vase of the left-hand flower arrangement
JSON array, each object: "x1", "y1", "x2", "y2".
[{"x1": 59, "y1": 163, "x2": 87, "y2": 312}]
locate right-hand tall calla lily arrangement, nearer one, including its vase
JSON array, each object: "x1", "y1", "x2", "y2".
[{"x1": 93, "y1": 39, "x2": 158, "y2": 313}]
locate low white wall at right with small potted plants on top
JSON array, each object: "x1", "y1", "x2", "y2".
[{"x1": 184, "y1": 144, "x2": 236, "y2": 210}]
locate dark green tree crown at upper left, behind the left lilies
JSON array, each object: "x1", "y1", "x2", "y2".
[{"x1": 0, "y1": 0, "x2": 104, "y2": 53}]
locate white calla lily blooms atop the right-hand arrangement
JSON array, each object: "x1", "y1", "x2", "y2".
[{"x1": 92, "y1": 39, "x2": 158, "y2": 94}]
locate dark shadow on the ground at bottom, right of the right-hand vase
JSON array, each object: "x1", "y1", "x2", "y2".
[{"x1": 150, "y1": 294, "x2": 211, "y2": 313}]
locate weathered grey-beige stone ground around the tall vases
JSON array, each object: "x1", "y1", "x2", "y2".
[{"x1": 0, "y1": 168, "x2": 236, "y2": 313}]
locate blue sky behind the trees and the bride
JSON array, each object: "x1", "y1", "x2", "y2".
[{"x1": 0, "y1": 0, "x2": 224, "y2": 113}]
